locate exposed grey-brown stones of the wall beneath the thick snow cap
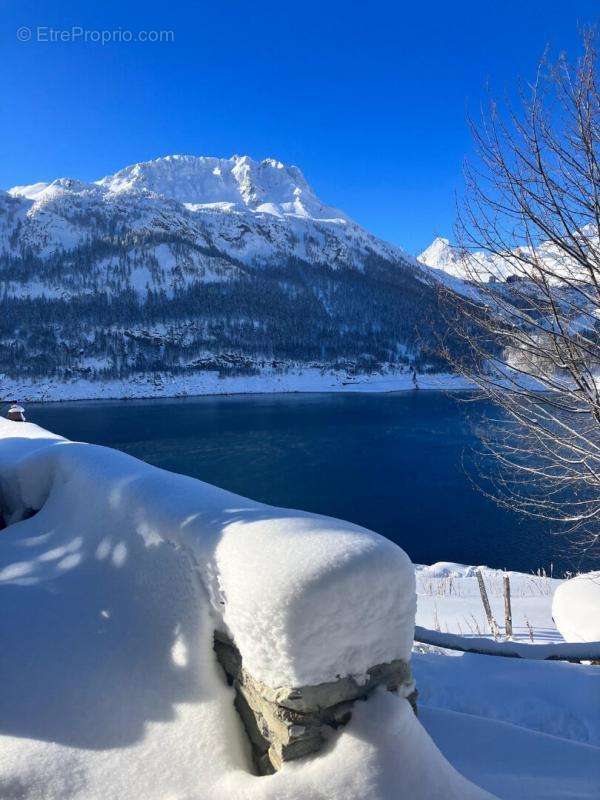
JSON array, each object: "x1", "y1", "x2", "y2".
[{"x1": 214, "y1": 631, "x2": 417, "y2": 775}]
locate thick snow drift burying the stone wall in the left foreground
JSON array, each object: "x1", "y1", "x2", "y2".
[{"x1": 0, "y1": 420, "x2": 488, "y2": 800}]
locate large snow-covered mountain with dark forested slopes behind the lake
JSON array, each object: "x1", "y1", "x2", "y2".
[{"x1": 0, "y1": 156, "x2": 464, "y2": 394}]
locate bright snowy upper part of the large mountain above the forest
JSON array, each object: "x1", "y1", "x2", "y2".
[{"x1": 5, "y1": 150, "x2": 410, "y2": 263}]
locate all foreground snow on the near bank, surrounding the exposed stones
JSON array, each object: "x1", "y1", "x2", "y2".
[{"x1": 0, "y1": 420, "x2": 600, "y2": 800}]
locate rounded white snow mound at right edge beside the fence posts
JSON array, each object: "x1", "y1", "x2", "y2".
[{"x1": 552, "y1": 571, "x2": 600, "y2": 642}]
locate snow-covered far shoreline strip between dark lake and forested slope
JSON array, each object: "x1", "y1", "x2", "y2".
[{"x1": 0, "y1": 369, "x2": 472, "y2": 402}]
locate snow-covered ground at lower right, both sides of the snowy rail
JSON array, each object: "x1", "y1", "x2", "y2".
[{"x1": 413, "y1": 563, "x2": 600, "y2": 800}]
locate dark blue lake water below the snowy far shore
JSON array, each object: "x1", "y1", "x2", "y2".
[{"x1": 28, "y1": 392, "x2": 581, "y2": 573}]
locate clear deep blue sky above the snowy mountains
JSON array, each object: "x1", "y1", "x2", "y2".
[{"x1": 0, "y1": 0, "x2": 600, "y2": 253}]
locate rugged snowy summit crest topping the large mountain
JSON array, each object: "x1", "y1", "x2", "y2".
[{"x1": 97, "y1": 155, "x2": 348, "y2": 221}]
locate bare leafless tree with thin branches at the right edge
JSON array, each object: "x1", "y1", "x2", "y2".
[{"x1": 444, "y1": 34, "x2": 600, "y2": 548}]
